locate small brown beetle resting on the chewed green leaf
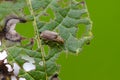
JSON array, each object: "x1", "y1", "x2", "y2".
[{"x1": 40, "y1": 30, "x2": 64, "y2": 43}]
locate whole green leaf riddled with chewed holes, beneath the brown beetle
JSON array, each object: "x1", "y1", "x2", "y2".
[{"x1": 0, "y1": 0, "x2": 93, "y2": 80}]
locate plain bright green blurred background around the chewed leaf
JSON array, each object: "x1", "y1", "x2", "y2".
[{"x1": 17, "y1": 0, "x2": 120, "y2": 80}]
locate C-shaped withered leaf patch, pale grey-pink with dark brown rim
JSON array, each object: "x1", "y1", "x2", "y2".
[{"x1": 0, "y1": 15, "x2": 26, "y2": 43}]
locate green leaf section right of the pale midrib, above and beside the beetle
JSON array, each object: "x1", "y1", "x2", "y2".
[{"x1": 32, "y1": 0, "x2": 92, "y2": 53}]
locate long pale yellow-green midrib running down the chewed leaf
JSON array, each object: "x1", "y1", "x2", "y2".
[{"x1": 26, "y1": 0, "x2": 48, "y2": 80}]
